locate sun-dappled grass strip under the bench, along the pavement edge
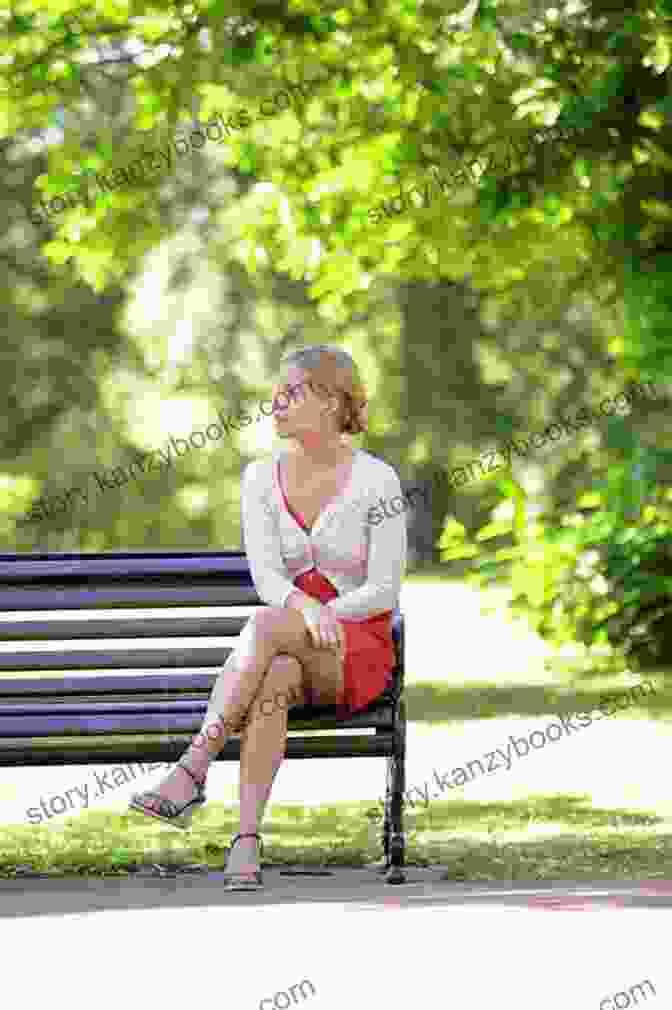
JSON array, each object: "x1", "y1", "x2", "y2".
[{"x1": 0, "y1": 795, "x2": 672, "y2": 881}]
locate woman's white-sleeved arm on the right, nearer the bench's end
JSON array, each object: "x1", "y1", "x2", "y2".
[{"x1": 325, "y1": 467, "x2": 406, "y2": 620}]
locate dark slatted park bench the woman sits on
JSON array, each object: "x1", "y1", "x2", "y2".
[{"x1": 0, "y1": 551, "x2": 406, "y2": 884}]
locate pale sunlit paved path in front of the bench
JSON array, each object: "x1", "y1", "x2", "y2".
[{"x1": 0, "y1": 868, "x2": 672, "y2": 1010}]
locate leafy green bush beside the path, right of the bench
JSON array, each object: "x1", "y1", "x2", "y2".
[{"x1": 439, "y1": 446, "x2": 672, "y2": 669}]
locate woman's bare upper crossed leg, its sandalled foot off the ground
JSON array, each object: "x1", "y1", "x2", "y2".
[{"x1": 135, "y1": 607, "x2": 342, "y2": 812}]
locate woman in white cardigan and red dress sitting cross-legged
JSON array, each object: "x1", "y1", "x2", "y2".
[{"x1": 130, "y1": 344, "x2": 406, "y2": 890}]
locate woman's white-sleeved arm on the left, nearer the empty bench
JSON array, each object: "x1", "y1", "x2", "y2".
[{"x1": 241, "y1": 460, "x2": 297, "y2": 607}]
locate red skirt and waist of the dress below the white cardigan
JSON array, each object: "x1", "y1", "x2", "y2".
[{"x1": 294, "y1": 569, "x2": 396, "y2": 715}]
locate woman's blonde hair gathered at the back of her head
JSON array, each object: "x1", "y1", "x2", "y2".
[{"x1": 281, "y1": 343, "x2": 368, "y2": 435}]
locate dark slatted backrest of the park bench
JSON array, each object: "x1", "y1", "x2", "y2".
[{"x1": 0, "y1": 551, "x2": 403, "y2": 698}]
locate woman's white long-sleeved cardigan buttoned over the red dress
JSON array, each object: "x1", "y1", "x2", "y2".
[{"x1": 242, "y1": 449, "x2": 406, "y2": 620}]
